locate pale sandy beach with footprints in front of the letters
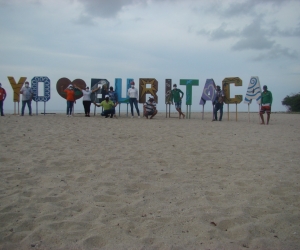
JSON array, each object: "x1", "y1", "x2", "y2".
[{"x1": 0, "y1": 112, "x2": 300, "y2": 250}]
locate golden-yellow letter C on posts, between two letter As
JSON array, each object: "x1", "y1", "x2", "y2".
[{"x1": 222, "y1": 77, "x2": 243, "y2": 121}]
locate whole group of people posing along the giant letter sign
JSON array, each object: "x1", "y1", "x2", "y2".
[{"x1": 0, "y1": 81, "x2": 273, "y2": 125}]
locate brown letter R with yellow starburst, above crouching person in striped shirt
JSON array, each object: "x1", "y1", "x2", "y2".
[{"x1": 139, "y1": 78, "x2": 158, "y2": 103}]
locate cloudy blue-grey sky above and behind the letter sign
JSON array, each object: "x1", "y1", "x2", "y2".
[{"x1": 0, "y1": 0, "x2": 300, "y2": 112}]
